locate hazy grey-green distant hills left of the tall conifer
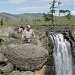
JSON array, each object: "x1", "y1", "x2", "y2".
[{"x1": 0, "y1": 12, "x2": 43, "y2": 21}]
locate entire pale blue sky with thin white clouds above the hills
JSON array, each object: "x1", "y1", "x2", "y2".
[{"x1": 0, "y1": 0, "x2": 75, "y2": 15}]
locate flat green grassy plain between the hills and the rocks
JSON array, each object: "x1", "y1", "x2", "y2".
[{"x1": 2, "y1": 18, "x2": 75, "y2": 27}]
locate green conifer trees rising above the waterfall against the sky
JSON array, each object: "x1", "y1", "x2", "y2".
[{"x1": 43, "y1": 0, "x2": 72, "y2": 24}]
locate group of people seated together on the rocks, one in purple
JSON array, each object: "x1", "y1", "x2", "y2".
[{"x1": 14, "y1": 25, "x2": 35, "y2": 43}]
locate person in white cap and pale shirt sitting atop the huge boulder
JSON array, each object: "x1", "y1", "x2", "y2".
[{"x1": 22, "y1": 25, "x2": 35, "y2": 43}]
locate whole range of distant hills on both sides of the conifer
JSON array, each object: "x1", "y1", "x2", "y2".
[{"x1": 0, "y1": 12, "x2": 75, "y2": 22}]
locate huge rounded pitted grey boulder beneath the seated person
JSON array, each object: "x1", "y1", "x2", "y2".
[{"x1": 0, "y1": 44, "x2": 48, "y2": 70}]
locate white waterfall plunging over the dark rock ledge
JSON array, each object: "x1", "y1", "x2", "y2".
[{"x1": 50, "y1": 33, "x2": 73, "y2": 75}]
